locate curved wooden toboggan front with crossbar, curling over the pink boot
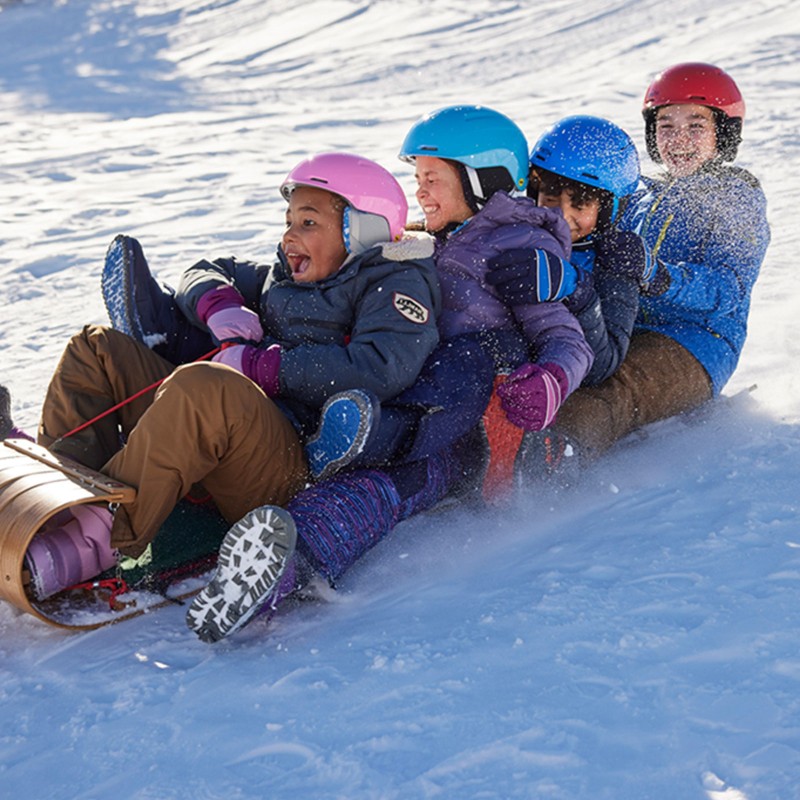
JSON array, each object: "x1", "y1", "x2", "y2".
[{"x1": 0, "y1": 439, "x2": 136, "y2": 628}]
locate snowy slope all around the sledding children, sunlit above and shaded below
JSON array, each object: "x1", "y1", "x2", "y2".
[{"x1": 0, "y1": 0, "x2": 800, "y2": 800}]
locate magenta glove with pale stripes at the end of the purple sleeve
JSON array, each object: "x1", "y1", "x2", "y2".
[{"x1": 497, "y1": 364, "x2": 569, "y2": 431}]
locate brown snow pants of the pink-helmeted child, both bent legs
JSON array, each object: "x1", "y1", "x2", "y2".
[{"x1": 39, "y1": 326, "x2": 307, "y2": 557}]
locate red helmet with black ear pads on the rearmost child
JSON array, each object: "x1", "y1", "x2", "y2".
[{"x1": 642, "y1": 62, "x2": 745, "y2": 163}]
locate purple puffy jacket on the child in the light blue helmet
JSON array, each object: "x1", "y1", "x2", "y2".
[{"x1": 434, "y1": 192, "x2": 594, "y2": 392}]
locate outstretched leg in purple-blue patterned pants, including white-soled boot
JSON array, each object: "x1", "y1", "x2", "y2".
[{"x1": 186, "y1": 446, "x2": 472, "y2": 642}]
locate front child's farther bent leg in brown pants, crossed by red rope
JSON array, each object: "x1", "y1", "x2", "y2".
[{"x1": 39, "y1": 326, "x2": 174, "y2": 469}]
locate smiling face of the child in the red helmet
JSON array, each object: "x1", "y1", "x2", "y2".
[{"x1": 656, "y1": 103, "x2": 717, "y2": 178}]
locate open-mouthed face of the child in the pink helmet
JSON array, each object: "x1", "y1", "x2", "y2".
[{"x1": 281, "y1": 186, "x2": 347, "y2": 283}]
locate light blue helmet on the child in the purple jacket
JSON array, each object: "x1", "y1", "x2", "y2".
[{"x1": 399, "y1": 105, "x2": 528, "y2": 207}]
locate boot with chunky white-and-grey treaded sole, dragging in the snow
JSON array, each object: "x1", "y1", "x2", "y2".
[{"x1": 186, "y1": 506, "x2": 297, "y2": 642}]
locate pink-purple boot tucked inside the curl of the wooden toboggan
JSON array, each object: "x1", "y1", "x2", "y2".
[{"x1": 25, "y1": 505, "x2": 117, "y2": 600}]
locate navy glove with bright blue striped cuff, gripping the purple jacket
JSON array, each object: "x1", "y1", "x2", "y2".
[{"x1": 486, "y1": 249, "x2": 578, "y2": 307}]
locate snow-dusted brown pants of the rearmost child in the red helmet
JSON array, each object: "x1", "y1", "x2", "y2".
[{"x1": 555, "y1": 331, "x2": 712, "y2": 462}]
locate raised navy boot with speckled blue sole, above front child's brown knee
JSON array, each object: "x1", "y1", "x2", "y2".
[{"x1": 100, "y1": 234, "x2": 214, "y2": 364}]
